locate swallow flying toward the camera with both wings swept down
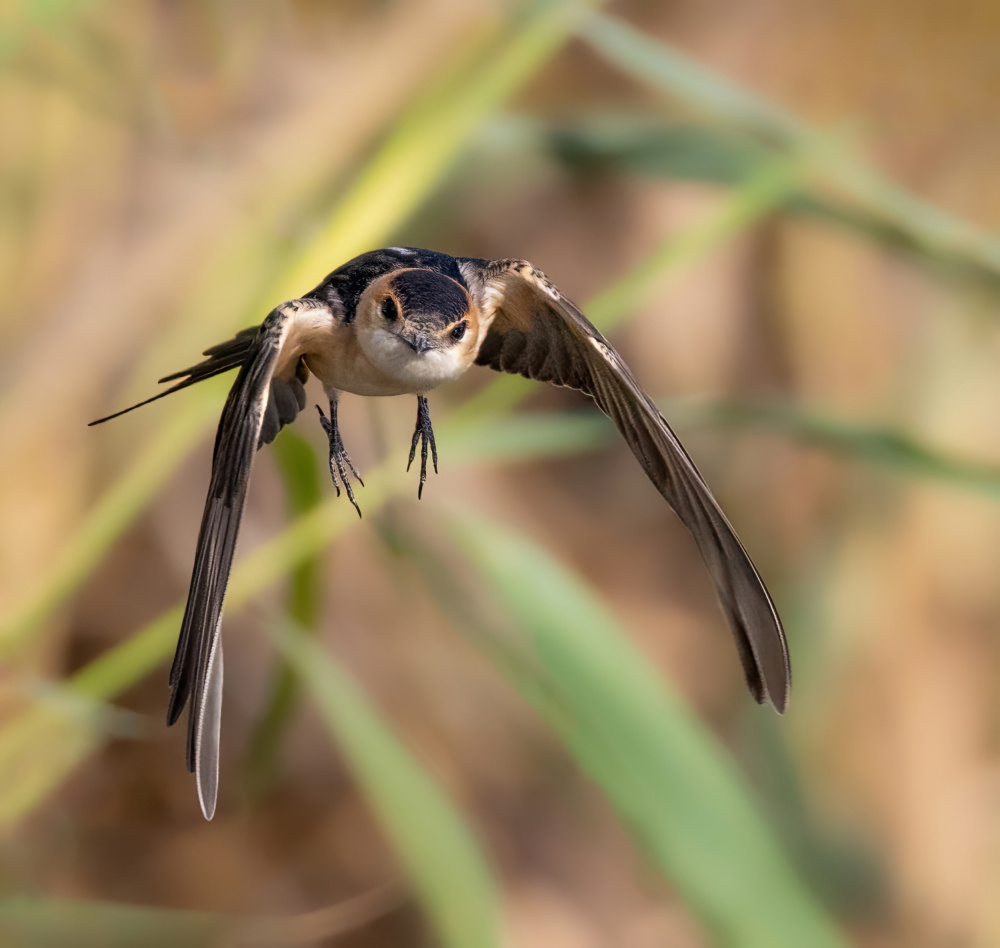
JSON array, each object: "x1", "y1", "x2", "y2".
[{"x1": 91, "y1": 247, "x2": 791, "y2": 819}]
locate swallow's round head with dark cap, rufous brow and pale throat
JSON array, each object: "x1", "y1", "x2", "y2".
[{"x1": 356, "y1": 268, "x2": 479, "y2": 391}]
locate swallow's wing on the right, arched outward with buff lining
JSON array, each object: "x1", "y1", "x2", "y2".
[{"x1": 459, "y1": 259, "x2": 791, "y2": 711}]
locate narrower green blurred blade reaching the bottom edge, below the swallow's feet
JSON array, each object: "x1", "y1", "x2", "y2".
[{"x1": 277, "y1": 630, "x2": 500, "y2": 948}]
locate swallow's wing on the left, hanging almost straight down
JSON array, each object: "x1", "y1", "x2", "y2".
[{"x1": 167, "y1": 300, "x2": 325, "y2": 819}]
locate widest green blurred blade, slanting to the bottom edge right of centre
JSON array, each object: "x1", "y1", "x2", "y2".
[{"x1": 438, "y1": 513, "x2": 843, "y2": 948}]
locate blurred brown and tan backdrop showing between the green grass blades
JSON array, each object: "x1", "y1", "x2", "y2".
[{"x1": 0, "y1": 0, "x2": 1000, "y2": 948}]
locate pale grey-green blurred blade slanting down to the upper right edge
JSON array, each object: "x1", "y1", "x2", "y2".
[{"x1": 580, "y1": 13, "x2": 1000, "y2": 283}]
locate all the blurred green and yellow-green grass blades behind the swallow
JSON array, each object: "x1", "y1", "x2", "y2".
[{"x1": 0, "y1": 0, "x2": 1000, "y2": 946}]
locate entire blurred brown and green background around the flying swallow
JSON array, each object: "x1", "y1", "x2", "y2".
[{"x1": 0, "y1": 0, "x2": 1000, "y2": 948}]
